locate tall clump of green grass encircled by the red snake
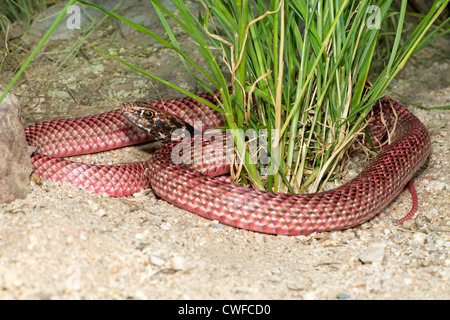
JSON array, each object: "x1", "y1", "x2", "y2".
[{"x1": 93, "y1": 0, "x2": 448, "y2": 192}]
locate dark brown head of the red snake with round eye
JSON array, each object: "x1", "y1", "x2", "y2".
[{"x1": 120, "y1": 102, "x2": 194, "y2": 140}]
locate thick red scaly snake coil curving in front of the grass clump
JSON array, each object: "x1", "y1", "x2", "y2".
[{"x1": 149, "y1": 99, "x2": 430, "y2": 235}]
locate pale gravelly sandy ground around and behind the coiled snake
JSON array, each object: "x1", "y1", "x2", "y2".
[{"x1": 0, "y1": 1, "x2": 450, "y2": 299}]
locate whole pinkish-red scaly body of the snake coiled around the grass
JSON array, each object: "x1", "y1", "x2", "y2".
[{"x1": 26, "y1": 94, "x2": 431, "y2": 235}]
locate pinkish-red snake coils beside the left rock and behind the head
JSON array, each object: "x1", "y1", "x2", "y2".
[{"x1": 25, "y1": 94, "x2": 224, "y2": 197}]
